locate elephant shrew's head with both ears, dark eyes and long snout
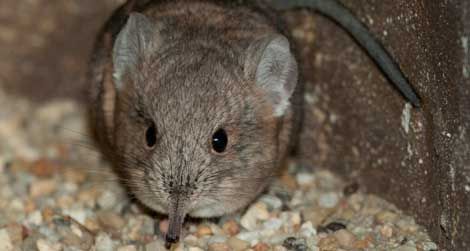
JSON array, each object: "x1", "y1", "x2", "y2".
[{"x1": 98, "y1": 13, "x2": 297, "y2": 241}]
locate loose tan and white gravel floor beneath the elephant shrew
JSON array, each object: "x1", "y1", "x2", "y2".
[{"x1": 0, "y1": 89, "x2": 437, "y2": 251}]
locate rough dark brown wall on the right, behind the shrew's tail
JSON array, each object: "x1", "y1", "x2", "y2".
[{"x1": 290, "y1": 0, "x2": 470, "y2": 250}]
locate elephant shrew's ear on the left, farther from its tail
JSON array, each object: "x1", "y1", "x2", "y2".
[{"x1": 112, "y1": 12, "x2": 161, "y2": 90}]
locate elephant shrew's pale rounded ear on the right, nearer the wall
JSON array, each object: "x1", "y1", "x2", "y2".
[{"x1": 245, "y1": 35, "x2": 298, "y2": 117}]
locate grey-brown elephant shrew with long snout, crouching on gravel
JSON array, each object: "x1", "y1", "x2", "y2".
[{"x1": 90, "y1": 0, "x2": 414, "y2": 246}]
